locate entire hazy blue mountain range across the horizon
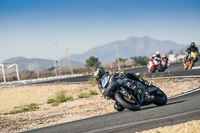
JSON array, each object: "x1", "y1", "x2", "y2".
[{"x1": 3, "y1": 36, "x2": 196, "y2": 71}]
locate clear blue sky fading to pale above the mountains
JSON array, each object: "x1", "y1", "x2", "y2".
[{"x1": 0, "y1": 0, "x2": 200, "y2": 62}]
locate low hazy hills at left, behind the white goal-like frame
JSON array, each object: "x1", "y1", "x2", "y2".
[{"x1": 3, "y1": 57, "x2": 84, "y2": 72}]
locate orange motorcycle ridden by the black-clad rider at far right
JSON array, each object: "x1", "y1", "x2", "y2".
[{"x1": 183, "y1": 52, "x2": 198, "y2": 70}]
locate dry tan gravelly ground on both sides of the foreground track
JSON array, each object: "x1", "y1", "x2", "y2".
[{"x1": 0, "y1": 78, "x2": 200, "y2": 133}]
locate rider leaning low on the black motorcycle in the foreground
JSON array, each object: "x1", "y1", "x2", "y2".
[{"x1": 93, "y1": 67, "x2": 152, "y2": 93}]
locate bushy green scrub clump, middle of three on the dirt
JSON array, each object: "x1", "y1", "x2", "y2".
[{"x1": 47, "y1": 91, "x2": 74, "y2": 106}]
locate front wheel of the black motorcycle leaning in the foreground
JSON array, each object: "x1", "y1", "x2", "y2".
[{"x1": 115, "y1": 92, "x2": 141, "y2": 111}]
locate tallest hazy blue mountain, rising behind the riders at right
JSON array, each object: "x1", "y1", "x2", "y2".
[{"x1": 70, "y1": 36, "x2": 184, "y2": 63}]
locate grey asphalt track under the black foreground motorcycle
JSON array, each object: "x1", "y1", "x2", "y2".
[{"x1": 21, "y1": 89, "x2": 200, "y2": 133}]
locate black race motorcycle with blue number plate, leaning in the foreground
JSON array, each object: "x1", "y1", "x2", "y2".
[{"x1": 101, "y1": 73, "x2": 167, "y2": 111}]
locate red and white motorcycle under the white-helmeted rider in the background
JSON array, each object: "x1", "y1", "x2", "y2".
[{"x1": 147, "y1": 58, "x2": 160, "y2": 73}]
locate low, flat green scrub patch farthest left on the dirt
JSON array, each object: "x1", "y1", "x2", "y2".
[{"x1": 4, "y1": 103, "x2": 39, "y2": 115}]
